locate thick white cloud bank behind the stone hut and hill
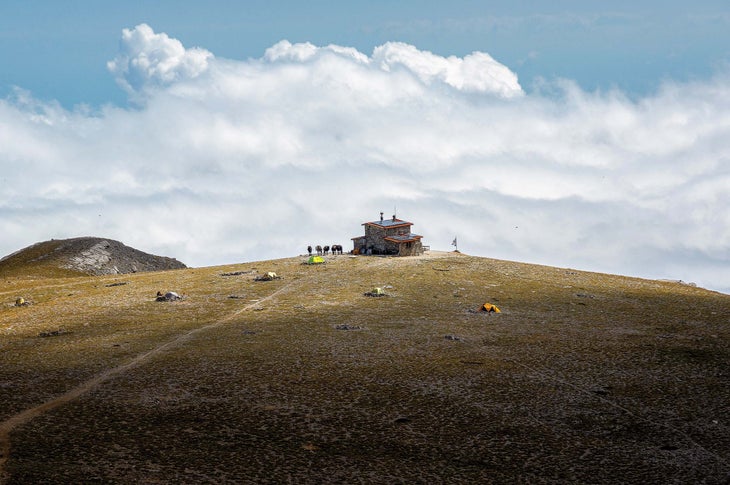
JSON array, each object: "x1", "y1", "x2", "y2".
[{"x1": 0, "y1": 25, "x2": 730, "y2": 292}]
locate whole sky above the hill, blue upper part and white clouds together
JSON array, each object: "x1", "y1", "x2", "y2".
[{"x1": 0, "y1": 0, "x2": 730, "y2": 292}]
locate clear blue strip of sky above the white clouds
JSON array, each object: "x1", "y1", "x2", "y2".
[{"x1": 5, "y1": 0, "x2": 730, "y2": 106}]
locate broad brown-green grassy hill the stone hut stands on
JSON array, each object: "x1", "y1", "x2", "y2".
[{"x1": 0, "y1": 252, "x2": 730, "y2": 484}]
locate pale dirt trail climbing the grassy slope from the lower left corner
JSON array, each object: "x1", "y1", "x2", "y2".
[{"x1": 0, "y1": 281, "x2": 294, "y2": 484}]
